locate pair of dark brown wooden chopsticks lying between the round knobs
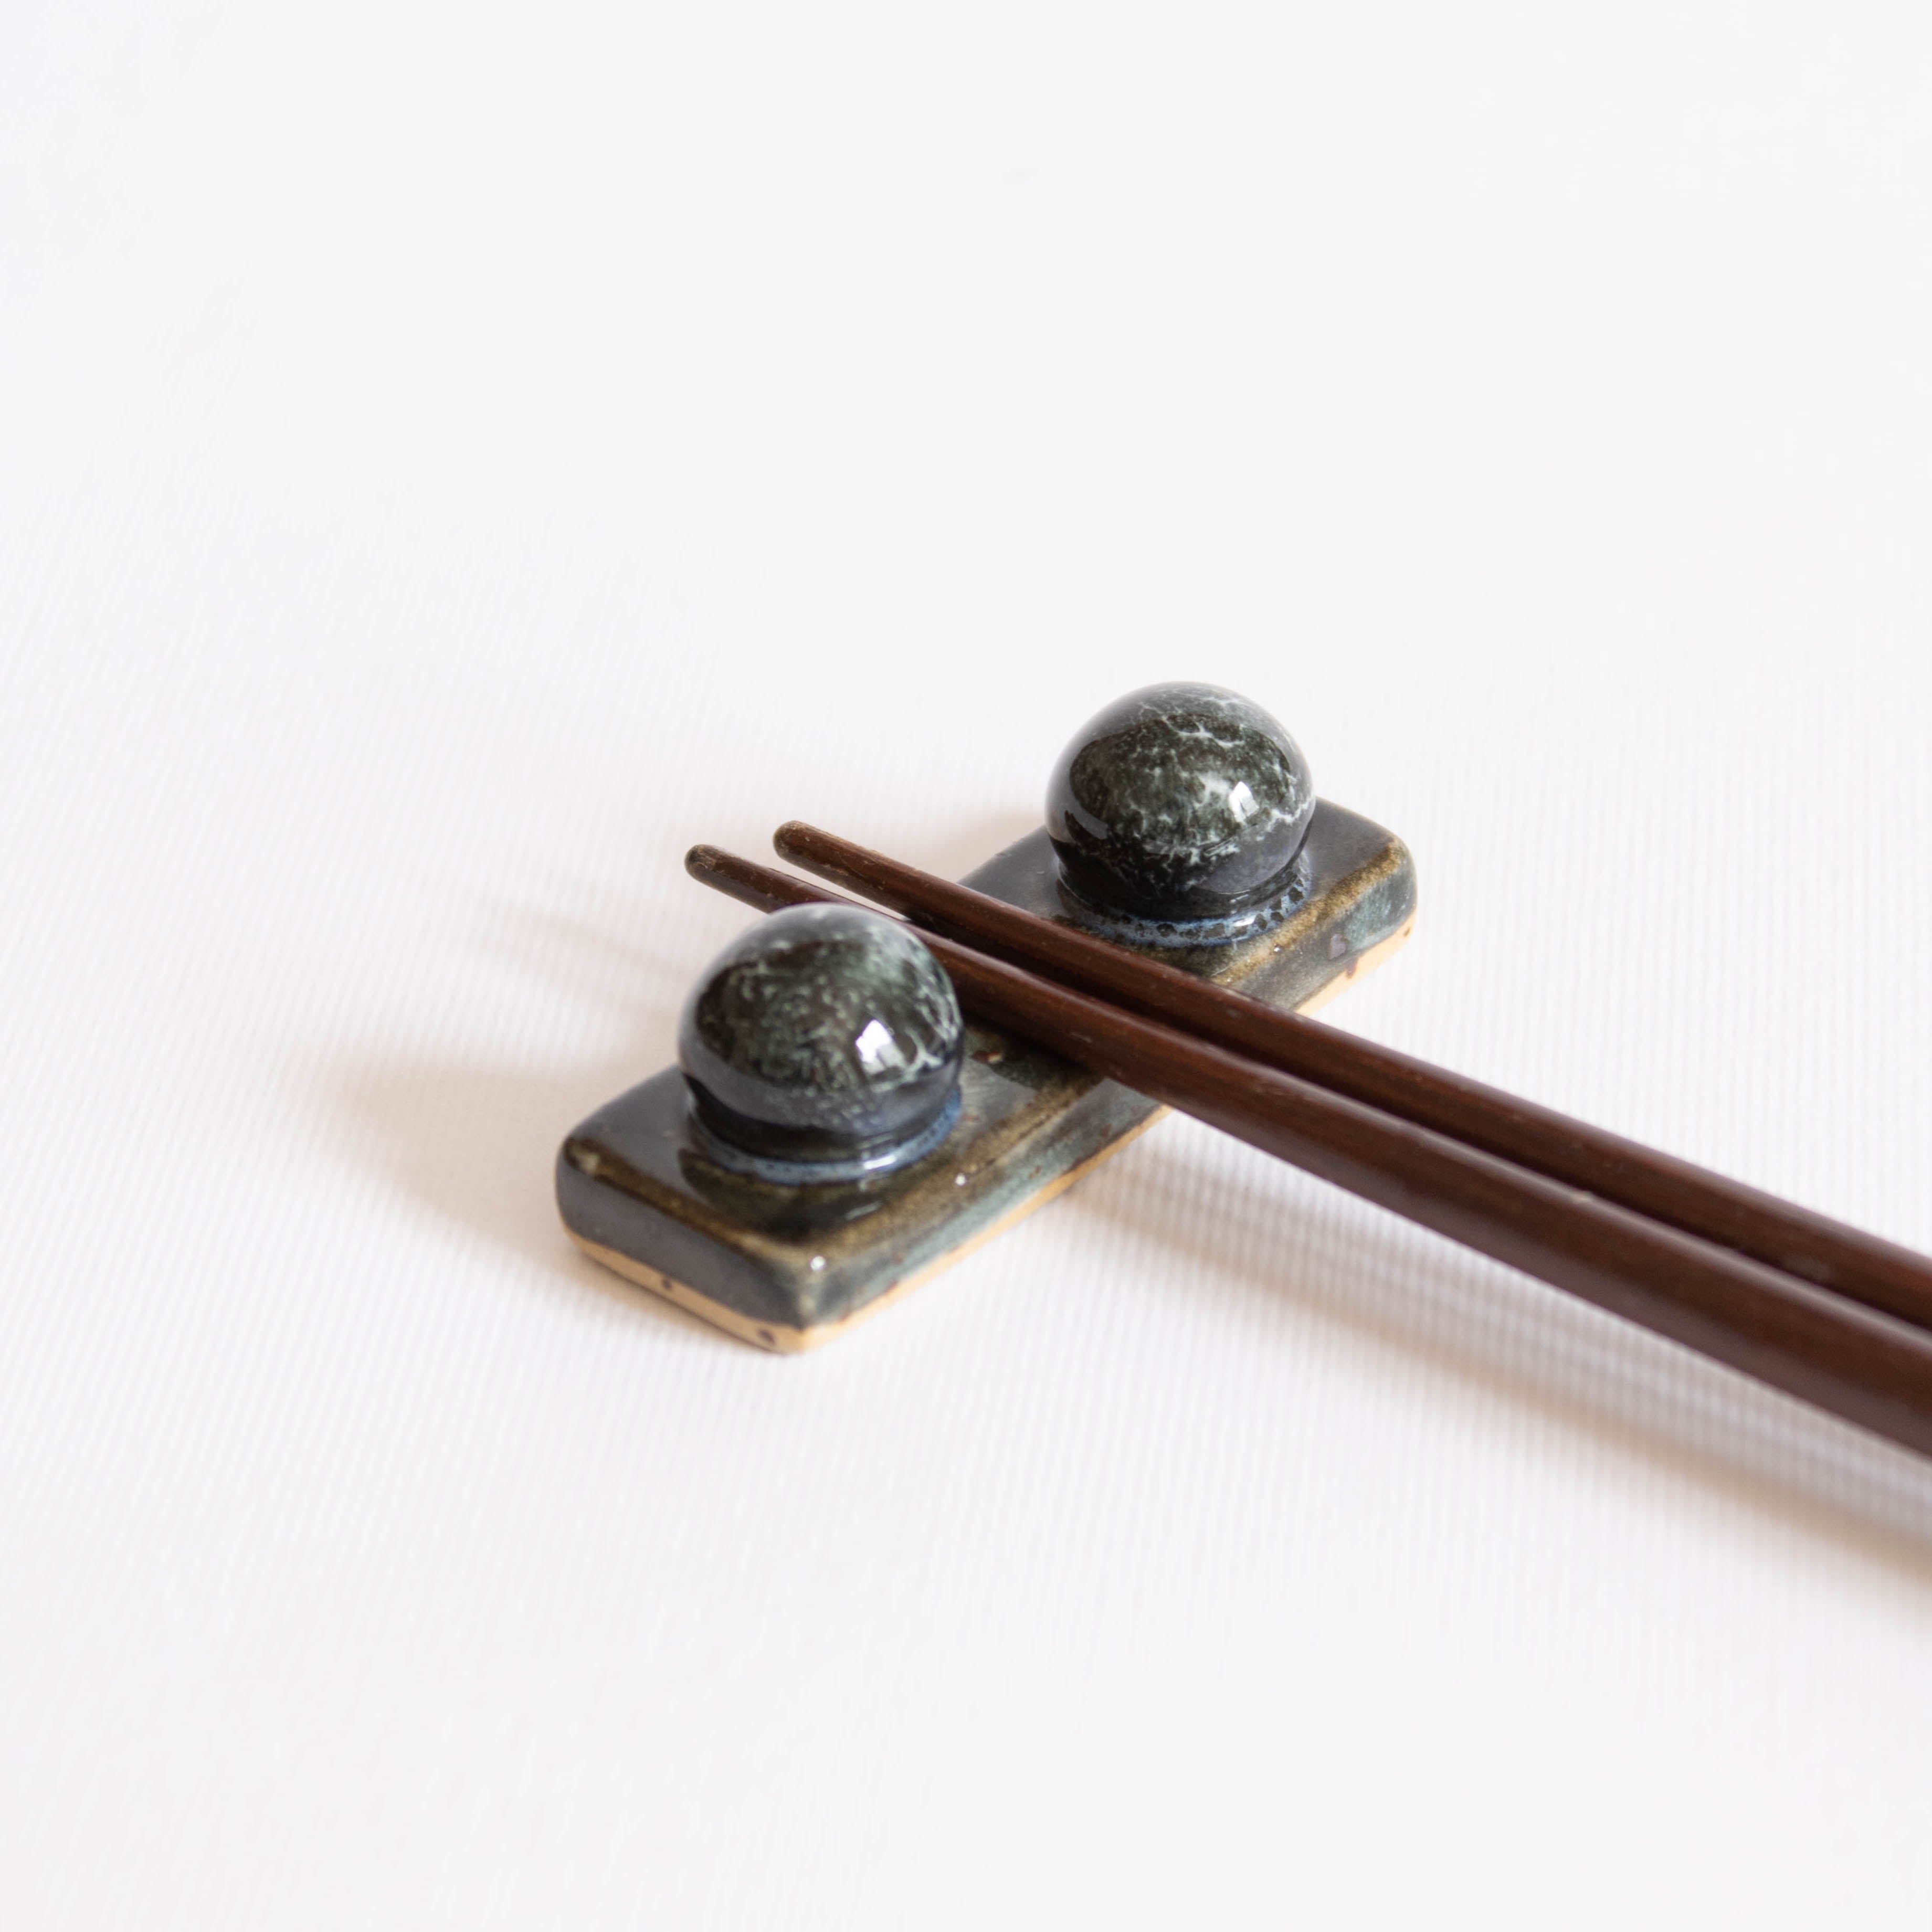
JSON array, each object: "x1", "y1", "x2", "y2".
[{"x1": 684, "y1": 823, "x2": 1932, "y2": 1455}]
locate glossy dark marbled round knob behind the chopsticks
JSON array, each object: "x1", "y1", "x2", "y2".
[{"x1": 1047, "y1": 684, "x2": 1316, "y2": 943}]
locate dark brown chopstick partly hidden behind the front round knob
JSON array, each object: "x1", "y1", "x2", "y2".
[{"x1": 684, "y1": 846, "x2": 1932, "y2": 1455}]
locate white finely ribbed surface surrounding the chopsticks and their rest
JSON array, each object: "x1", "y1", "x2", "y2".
[{"x1": 0, "y1": 0, "x2": 1932, "y2": 1932}]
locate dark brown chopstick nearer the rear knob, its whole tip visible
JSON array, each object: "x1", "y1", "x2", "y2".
[{"x1": 773, "y1": 821, "x2": 1932, "y2": 1329}]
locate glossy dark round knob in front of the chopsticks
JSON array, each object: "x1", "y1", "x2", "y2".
[{"x1": 678, "y1": 906, "x2": 966, "y2": 1180}]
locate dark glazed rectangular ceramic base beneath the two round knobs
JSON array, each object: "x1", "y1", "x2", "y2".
[{"x1": 556, "y1": 804, "x2": 1414, "y2": 1348}]
